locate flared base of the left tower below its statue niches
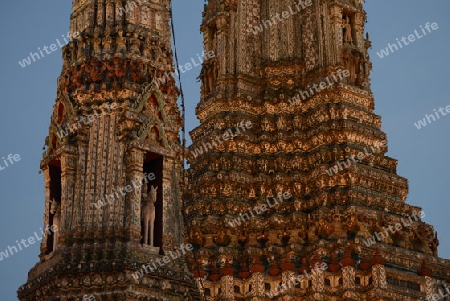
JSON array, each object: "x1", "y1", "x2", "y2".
[{"x1": 18, "y1": 243, "x2": 200, "y2": 301}]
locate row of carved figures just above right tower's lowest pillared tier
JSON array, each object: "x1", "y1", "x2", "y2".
[{"x1": 190, "y1": 210, "x2": 439, "y2": 256}]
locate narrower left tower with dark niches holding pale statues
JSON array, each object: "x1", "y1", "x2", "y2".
[{"x1": 18, "y1": 0, "x2": 196, "y2": 301}]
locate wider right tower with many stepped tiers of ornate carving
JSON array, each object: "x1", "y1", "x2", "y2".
[{"x1": 185, "y1": 0, "x2": 450, "y2": 300}]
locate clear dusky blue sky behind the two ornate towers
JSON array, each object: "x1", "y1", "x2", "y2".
[{"x1": 0, "y1": 0, "x2": 450, "y2": 300}]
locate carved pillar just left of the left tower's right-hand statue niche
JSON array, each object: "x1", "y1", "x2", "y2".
[{"x1": 125, "y1": 148, "x2": 144, "y2": 244}]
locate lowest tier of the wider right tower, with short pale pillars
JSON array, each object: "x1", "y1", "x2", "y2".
[{"x1": 193, "y1": 245, "x2": 449, "y2": 301}]
